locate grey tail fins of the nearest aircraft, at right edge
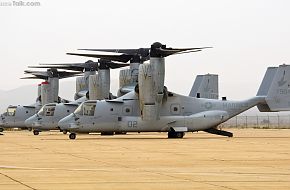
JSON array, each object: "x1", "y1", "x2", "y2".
[{"x1": 257, "y1": 65, "x2": 290, "y2": 111}]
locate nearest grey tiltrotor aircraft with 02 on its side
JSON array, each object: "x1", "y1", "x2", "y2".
[{"x1": 58, "y1": 43, "x2": 290, "y2": 139}]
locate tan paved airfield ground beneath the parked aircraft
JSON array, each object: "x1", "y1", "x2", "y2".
[{"x1": 0, "y1": 129, "x2": 290, "y2": 190}]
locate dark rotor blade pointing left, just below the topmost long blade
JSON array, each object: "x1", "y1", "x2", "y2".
[{"x1": 67, "y1": 53, "x2": 132, "y2": 63}]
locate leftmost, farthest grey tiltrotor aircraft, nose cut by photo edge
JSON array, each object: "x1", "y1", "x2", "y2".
[{"x1": 0, "y1": 69, "x2": 79, "y2": 132}]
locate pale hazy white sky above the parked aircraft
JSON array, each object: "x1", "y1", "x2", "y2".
[{"x1": 0, "y1": 0, "x2": 290, "y2": 99}]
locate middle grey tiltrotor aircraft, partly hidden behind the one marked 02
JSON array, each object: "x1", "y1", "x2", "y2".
[{"x1": 25, "y1": 59, "x2": 129, "y2": 135}]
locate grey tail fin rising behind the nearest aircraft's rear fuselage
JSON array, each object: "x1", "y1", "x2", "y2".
[{"x1": 189, "y1": 74, "x2": 218, "y2": 99}]
